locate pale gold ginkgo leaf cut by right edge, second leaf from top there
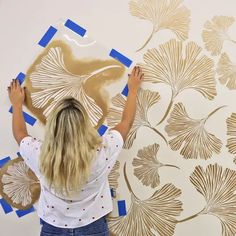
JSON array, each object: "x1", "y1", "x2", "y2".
[{"x1": 217, "y1": 53, "x2": 236, "y2": 90}]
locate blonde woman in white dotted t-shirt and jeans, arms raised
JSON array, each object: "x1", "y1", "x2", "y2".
[{"x1": 8, "y1": 67, "x2": 144, "y2": 236}]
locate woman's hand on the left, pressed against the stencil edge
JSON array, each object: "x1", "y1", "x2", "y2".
[{"x1": 8, "y1": 79, "x2": 25, "y2": 107}]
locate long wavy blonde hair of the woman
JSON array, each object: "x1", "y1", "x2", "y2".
[{"x1": 39, "y1": 98, "x2": 102, "y2": 195}]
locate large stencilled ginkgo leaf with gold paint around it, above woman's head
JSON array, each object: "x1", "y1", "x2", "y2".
[{"x1": 26, "y1": 41, "x2": 124, "y2": 126}]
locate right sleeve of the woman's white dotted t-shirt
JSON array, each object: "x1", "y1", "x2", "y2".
[{"x1": 103, "y1": 130, "x2": 124, "y2": 174}]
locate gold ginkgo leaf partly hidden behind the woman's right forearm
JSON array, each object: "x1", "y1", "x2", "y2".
[{"x1": 107, "y1": 88, "x2": 166, "y2": 149}]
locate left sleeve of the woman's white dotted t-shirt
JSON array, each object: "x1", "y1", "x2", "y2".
[{"x1": 20, "y1": 136, "x2": 42, "y2": 177}]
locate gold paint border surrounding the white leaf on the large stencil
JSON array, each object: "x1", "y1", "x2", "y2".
[{"x1": 25, "y1": 41, "x2": 125, "y2": 126}]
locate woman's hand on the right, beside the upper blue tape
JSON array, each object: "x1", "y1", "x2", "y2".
[{"x1": 128, "y1": 66, "x2": 144, "y2": 92}]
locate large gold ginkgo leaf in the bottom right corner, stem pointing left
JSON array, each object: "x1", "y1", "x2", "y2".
[{"x1": 184, "y1": 164, "x2": 236, "y2": 236}]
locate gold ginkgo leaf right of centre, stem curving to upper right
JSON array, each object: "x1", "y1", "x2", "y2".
[{"x1": 165, "y1": 103, "x2": 222, "y2": 160}]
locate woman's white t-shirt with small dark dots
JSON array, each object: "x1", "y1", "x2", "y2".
[{"x1": 20, "y1": 130, "x2": 123, "y2": 228}]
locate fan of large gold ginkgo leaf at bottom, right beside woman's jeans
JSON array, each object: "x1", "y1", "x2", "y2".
[{"x1": 108, "y1": 184, "x2": 182, "y2": 236}]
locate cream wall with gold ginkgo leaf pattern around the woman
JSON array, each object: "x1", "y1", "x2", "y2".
[{"x1": 0, "y1": 0, "x2": 236, "y2": 236}]
